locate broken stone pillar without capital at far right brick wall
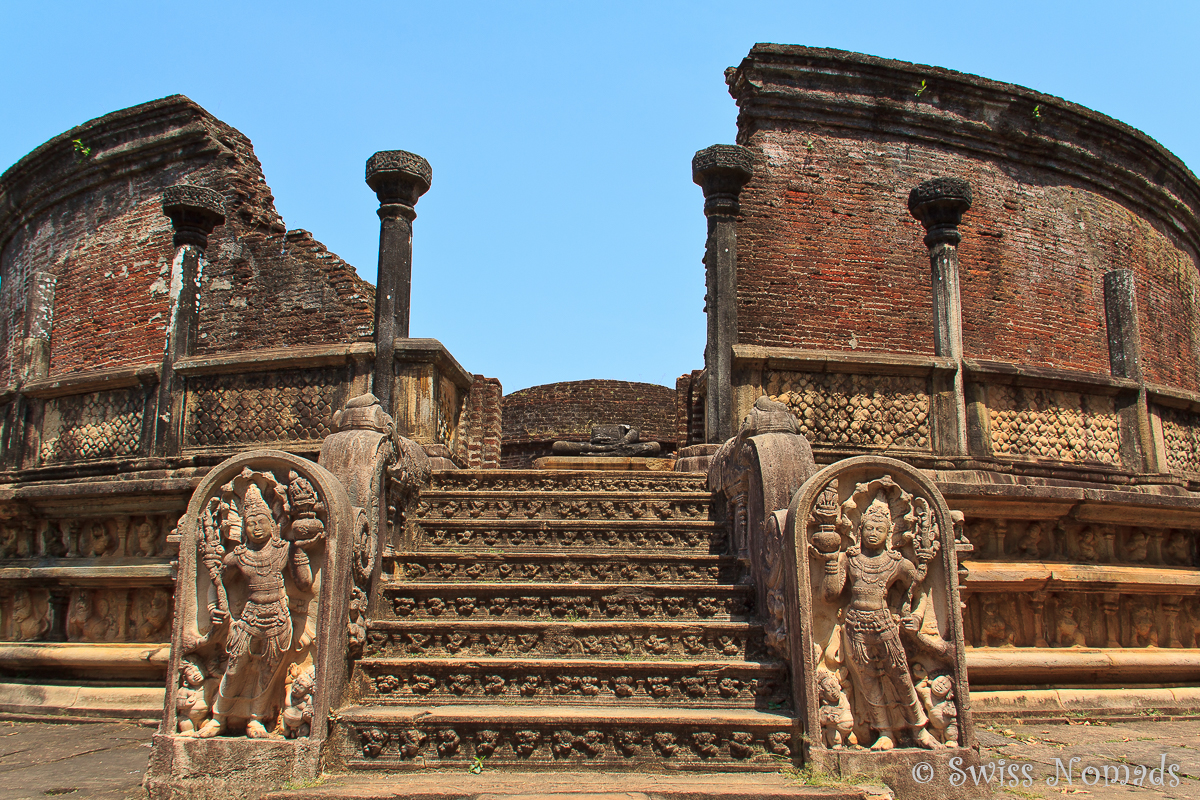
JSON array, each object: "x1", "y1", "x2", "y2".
[{"x1": 1104, "y1": 270, "x2": 1166, "y2": 473}]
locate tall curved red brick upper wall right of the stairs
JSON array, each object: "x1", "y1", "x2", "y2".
[{"x1": 731, "y1": 46, "x2": 1200, "y2": 391}]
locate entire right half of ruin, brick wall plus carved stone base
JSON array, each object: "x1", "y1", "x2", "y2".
[{"x1": 697, "y1": 44, "x2": 1200, "y2": 705}]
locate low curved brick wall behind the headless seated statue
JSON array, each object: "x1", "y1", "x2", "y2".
[{"x1": 502, "y1": 380, "x2": 679, "y2": 468}]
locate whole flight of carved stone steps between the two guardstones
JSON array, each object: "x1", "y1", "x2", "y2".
[{"x1": 334, "y1": 470, "x2": 799, "y2": 772}]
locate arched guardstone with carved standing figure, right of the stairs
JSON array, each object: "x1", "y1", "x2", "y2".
[{"x1": 782, "y1": 456, "x2": 979, "y2": 796}]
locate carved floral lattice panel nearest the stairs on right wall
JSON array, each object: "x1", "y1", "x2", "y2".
[{"x1": 763, "y1": 369, "x2": 930, "y2": 450}]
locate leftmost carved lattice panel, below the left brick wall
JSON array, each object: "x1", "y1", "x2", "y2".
[{"x1": 38, "y1": 387, "x2": 145, "y2": 464}]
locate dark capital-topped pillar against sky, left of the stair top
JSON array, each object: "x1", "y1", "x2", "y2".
[{"x1": 366, "y1": 150, "x2": 433, "y2": 416}]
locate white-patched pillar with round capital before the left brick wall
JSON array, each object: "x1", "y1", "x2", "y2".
[{"x1": 157, "y1": 184, "x2": 224, "y2": 456}]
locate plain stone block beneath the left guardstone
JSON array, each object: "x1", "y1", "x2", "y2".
[{"x1": 142, "y1": 734, "x2": 325, "y2": 800}]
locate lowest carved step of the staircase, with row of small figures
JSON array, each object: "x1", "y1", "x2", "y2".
[{"x1": 331, "y1": 704, "x2": 800, "y2": 771}]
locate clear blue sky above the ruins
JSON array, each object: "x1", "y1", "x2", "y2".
[{"x1": 0, "y1": 0, "x2": 1200, "y2": 391}]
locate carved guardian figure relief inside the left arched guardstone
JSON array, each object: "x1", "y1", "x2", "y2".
[{"x1": 177, "y1": 467, "x2": 325, "y2": 738}]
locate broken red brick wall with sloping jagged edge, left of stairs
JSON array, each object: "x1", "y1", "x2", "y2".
[{"x1": 0, "y1": 95, "x2": 374, "y2": 383}]
